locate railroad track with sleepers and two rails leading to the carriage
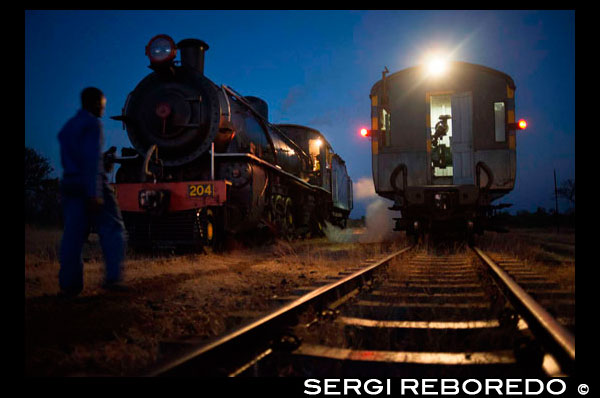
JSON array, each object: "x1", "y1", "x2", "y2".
[{"x1": 148, "y1": 247, "x2": 575, "y2": 377}]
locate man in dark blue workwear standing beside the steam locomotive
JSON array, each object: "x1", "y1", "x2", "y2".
[{"x1": 58, "y1": 87, "x2": 126, "y2": 297}]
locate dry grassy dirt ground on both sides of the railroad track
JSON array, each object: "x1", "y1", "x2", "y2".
[{"x1": 24, "y1": 226, "x2": 575, "y2": 376}]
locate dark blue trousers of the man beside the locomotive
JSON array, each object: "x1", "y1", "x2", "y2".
[{"x1": 58, "y1": 184, "x2": 125, "y2": 294}]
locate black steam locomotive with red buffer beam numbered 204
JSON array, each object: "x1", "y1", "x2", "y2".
[{"x1": 106, "y1": 35, "x2": 352, "y2": 247}]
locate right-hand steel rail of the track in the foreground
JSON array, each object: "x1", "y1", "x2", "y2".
[{"x1": 471, "y1": 246, "x2": 575, "y2": 372}]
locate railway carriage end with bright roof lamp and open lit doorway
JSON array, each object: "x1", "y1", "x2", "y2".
[{"x1": 369, "y1": 62, "x2": 524, "y2": 240}]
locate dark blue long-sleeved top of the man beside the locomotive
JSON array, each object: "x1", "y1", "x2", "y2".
[{"x1": 58, "y1": 109, "x2": 108, "y2": 198}]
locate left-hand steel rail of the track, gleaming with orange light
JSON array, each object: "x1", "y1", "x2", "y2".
[{"x1": 144, "y1": 246, "x2": 414, "y2": 376}]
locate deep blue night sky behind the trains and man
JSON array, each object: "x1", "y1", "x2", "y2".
[{"x1": 25, "y1": 10, "x2": 575, "y2": 218}]
